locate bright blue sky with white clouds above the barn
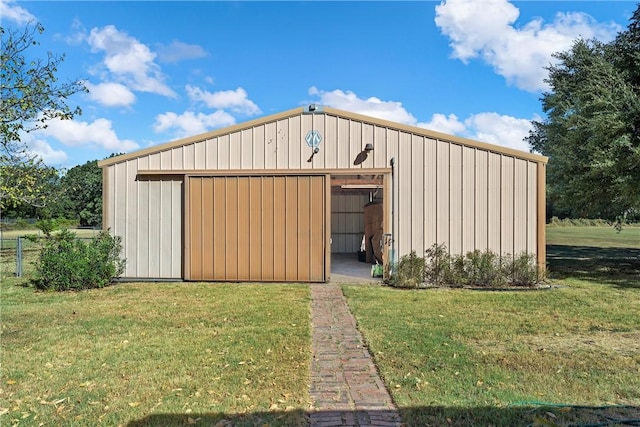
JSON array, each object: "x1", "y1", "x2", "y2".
[{"x1": 0, "y1": 0, "x2": 637, "y2": 168}]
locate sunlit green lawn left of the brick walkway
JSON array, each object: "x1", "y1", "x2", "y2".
[{"x1": 0, "y1": 281, "x2": 310, "y2": 426}]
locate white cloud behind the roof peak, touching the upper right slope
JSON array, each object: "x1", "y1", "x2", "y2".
[{"x1": 309, "y1": 86, "x2": 416, "y2": 125}]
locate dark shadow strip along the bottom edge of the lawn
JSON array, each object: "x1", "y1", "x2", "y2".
[{"x1": 128, "y1": 405, "x2": 640, "y2": 427}]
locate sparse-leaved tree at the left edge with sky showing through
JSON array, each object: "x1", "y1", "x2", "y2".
[{"x1": 0, "y1": 23, "x2": 86, "y2": 209}]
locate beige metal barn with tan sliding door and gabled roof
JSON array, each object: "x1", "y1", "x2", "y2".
[{"x1": 99, "y1": 105, "x2": 547, "y2": 282}]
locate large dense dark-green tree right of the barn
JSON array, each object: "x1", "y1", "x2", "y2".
[{"x1": 527, "y1": 6, "x2": 640, "y2": 220}]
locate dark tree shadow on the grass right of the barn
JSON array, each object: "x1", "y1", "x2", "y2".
[{"x1": 547, "y1": 245, "x2": 640, "y2": 289}]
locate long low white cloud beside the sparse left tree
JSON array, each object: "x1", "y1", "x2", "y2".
[{"x1": 37, "y1": 119, "x2": 139, "y2": 152}]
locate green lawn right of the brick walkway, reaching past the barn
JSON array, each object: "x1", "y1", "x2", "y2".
[{"x1": 343, "y1": 228, "x2": 640, "y2": 426}]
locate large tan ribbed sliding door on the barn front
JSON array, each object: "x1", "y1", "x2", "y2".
[{"x1": 187, "y1": 176, "x2": 325, "y2": 282}]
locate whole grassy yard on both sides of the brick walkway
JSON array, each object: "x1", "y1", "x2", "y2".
[{"x1": 0, "y1": 227, "x2": 640, "y2": 426}]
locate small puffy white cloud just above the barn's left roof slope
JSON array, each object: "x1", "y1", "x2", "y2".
[{"x1": 153, "y1": 110, "x2": 236, "y2": 138}]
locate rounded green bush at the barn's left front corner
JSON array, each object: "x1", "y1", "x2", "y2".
[{"x1": 31, "y1": 230, "x2": 125, "y2": 291}]
